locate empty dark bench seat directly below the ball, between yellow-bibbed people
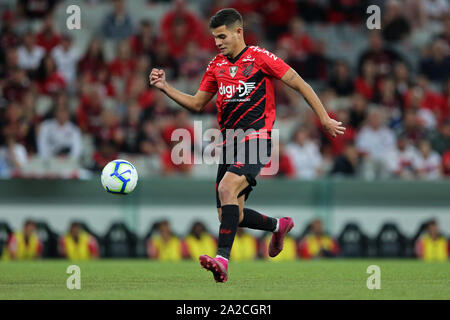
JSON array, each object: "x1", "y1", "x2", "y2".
[{"x1": 103, "y1": 222, "x2": 137, "y2": 258}]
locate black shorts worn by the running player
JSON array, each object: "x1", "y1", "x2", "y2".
[{"x1": 216, "y1": 139, "x2": 272, "y2": 208}]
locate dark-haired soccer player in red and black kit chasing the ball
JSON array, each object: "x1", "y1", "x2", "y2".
[{"x1": 149, "y1": 9, "x2": 345, "y2": 282}]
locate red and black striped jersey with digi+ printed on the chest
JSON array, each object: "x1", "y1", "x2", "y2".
[{"x1": 199, "y1": 46, "x2": 290, "y2": 138}]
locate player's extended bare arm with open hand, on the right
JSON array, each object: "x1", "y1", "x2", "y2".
[{"x1": 281, "y1": 68, "x2": 345, "y2": 137}]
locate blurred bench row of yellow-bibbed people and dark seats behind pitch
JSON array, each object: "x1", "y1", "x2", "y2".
[{"x1": 0, "y1": 218, "x2": 450, "y2": 262}]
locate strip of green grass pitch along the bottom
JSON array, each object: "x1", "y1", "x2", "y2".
[{"x1": 0, "y1": 259, "x2": 450, "y2": 300}]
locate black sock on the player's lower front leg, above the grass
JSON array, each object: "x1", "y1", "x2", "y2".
[{"x1": 217, "y1": 204, "x2": 239, "y2": 259}]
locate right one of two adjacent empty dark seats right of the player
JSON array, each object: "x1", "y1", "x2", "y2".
[{"x1": 375, "y1": 222, "x2": 410, "y2": 258}]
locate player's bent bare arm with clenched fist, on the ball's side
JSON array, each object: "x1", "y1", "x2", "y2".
[{"x1": 149, "y1": 68, "x2": 215, "y2": 112}]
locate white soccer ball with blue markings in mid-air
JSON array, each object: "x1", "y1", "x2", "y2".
[{"x1": 101, "y1": 159, "x2": 138, "y2": 194}]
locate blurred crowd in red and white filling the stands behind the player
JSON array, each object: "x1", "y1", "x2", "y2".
[{"x1": 0, "y1": 0, "x2": 450, "y2": 180}]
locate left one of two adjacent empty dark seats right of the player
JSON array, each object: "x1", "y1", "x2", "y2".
[{"x1": 338, "y1": 223, "x2": 370, "y2": 258}]
